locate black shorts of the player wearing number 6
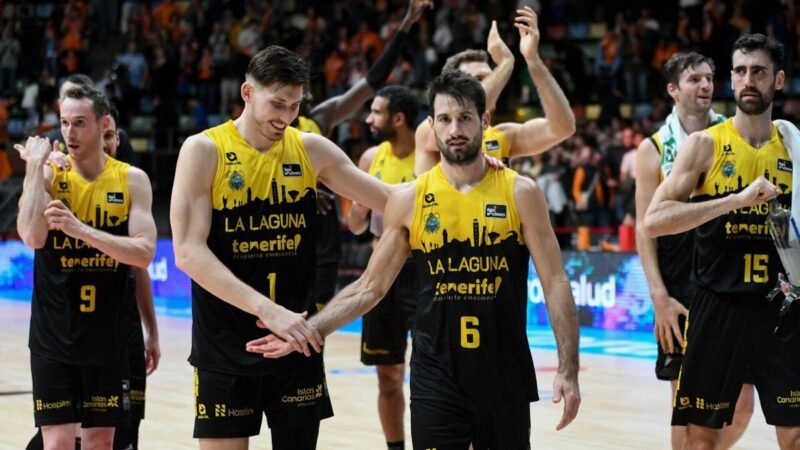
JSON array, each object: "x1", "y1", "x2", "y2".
[{"x1": 410, "y1": 358, "x2": 531, "y2": 450}]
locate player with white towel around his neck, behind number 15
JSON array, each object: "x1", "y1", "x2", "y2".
[{"x1": 636, "y1": 52, "x2": 754, "y2": 450}]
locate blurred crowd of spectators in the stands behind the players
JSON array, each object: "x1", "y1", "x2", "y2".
[{"x1": 0, "y1": 0, "x2": 800, "y2": 244}]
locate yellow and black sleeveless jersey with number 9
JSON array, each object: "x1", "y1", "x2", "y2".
[{"x1": 29, "y1": 157, "x2": 130, "y2": 366}]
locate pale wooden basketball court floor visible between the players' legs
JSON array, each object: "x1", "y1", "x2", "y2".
[{"x1": 0, "y1": 300, "x2": 778, "y2": 450}]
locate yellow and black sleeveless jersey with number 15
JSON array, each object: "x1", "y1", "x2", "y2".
[{"x1": 691, "y1": 119, "x2": 792, "y2": 296}]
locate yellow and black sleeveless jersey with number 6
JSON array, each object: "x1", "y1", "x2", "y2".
[{"x1": 409, "y1": 165, "x2": 538, "y2": 401}]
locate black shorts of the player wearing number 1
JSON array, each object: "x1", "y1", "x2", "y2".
[{"x1": 194, "y1": 353, "x2": 333, "y2": 438}]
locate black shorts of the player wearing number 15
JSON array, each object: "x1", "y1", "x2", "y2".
[{"x1": 672, "y1": 289, "x2": 800, "y2": 428}]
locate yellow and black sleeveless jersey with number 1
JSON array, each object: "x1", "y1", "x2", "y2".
[{"x1": 189, "y1": 121, "x2": 317, "y2": 375}]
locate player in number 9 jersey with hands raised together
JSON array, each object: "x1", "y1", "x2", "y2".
[{"x1": 17, "y1": 88, "x2": 156, "y2": 449}]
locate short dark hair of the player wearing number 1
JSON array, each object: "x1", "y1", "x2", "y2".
[{"x1": 247, "y1": 45, "x2": 308, "y2": 86}]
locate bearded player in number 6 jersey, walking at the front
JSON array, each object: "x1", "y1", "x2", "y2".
[{"x1": 248, "y1": 67, "x2": 580, "y2": 450}]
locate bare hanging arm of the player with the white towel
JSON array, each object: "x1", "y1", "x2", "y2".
[{"x1": 636, "y1": 139, "x2": 688, "y2": 353}]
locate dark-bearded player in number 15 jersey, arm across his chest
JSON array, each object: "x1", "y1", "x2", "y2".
[{"x1": 644, "y1": 34, "x2": 800, "y2": 449}]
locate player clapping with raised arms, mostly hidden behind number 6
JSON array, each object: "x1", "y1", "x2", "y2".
[{"x1": 415, "y1": 6, "x2": 575, "y2": 175}]
